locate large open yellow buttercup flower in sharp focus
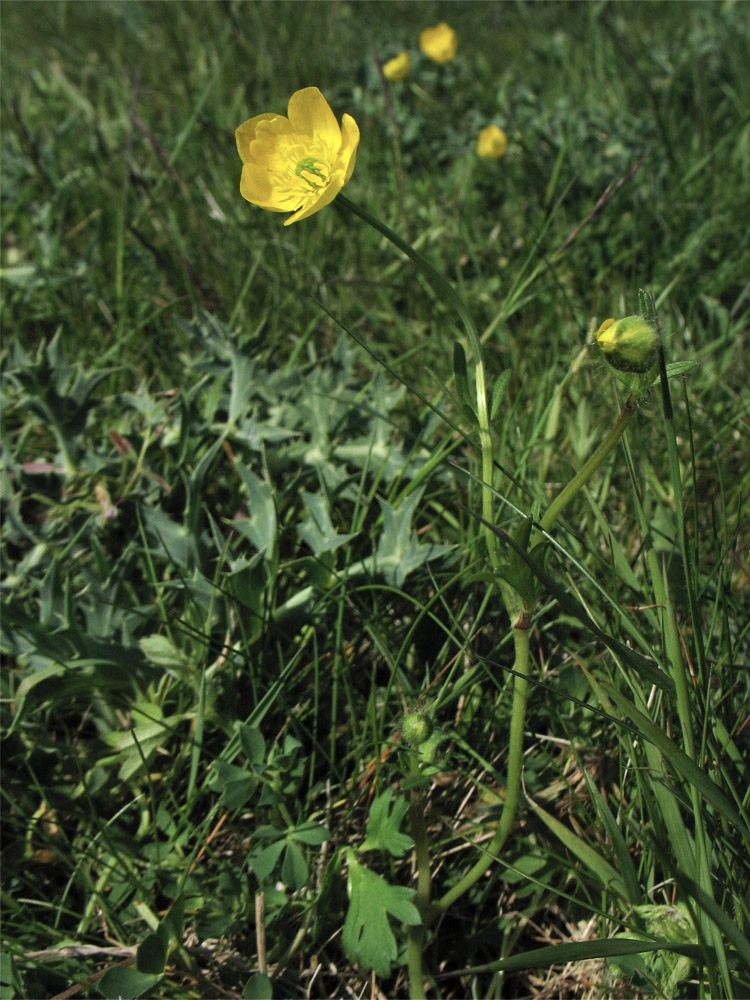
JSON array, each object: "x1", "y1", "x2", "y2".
[{"x1": 235, "y1": 87, "x2": 359, "y2": 226}]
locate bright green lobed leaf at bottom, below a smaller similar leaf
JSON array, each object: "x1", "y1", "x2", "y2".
[{"x1": 342, "y1": 851, "x2": 421, "y2": 977}]
